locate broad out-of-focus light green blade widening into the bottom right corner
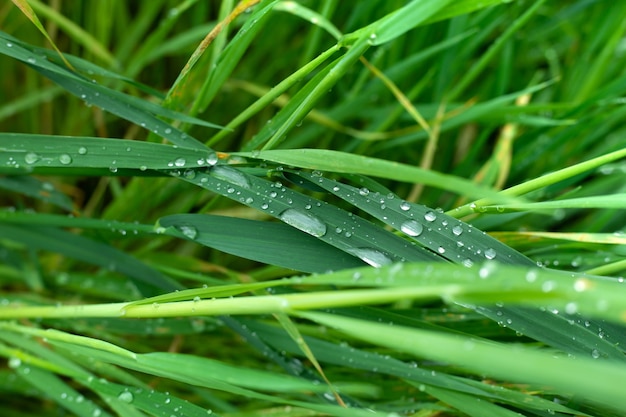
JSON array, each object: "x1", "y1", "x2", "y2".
[{"x1": 299, "y1": 312, "x2": 626, "y2": 411}]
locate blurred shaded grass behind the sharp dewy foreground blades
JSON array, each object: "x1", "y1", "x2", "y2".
[{"x1": 0, "y1": 0, "x2": 626, "y2": 415}]
